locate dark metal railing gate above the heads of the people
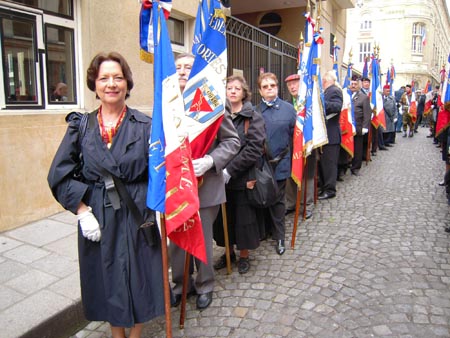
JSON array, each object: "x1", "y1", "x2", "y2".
[{"x1": 227, "y1": 17, "x2": 298, "y2": 104}]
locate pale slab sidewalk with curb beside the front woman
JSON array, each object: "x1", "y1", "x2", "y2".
[{"x1": 0, "y1": 212, "x2": 87, "y2": 338}]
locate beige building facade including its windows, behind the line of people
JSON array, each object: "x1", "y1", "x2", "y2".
[{"x1": 0, "y1": 0, "x2": 354, "y2": 231}]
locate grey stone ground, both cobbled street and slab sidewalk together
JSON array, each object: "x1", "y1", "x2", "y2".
[{"x1": 0, "y1": 128, "x2": 450, "y2": 338}]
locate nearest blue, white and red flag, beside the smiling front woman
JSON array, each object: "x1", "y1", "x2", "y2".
[{"x1": 147, "y1": 1, "x2": 206, "y2": 263}]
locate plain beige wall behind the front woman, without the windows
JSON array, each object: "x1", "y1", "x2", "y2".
[{"x1": 0, "y1": 0, "x2": 197, "y2": 232}]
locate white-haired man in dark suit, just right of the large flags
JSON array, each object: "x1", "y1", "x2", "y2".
[{"x1": 318, "y1": 70, "x2": 344, "y2": 200}]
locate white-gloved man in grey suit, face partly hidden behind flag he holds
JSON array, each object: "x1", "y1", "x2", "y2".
[{"x1": 169, "y1": 53, "x2": 240, "y2": 310}]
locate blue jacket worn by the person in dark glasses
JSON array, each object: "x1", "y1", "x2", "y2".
[{"x1": 255, "y1": 98, "x2": 297, "y2": 181}]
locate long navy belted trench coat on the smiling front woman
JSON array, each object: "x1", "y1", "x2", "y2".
[{"x1": 48, "y1": 108, "x2": 164, "y2": 327}]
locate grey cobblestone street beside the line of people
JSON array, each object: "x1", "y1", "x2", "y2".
[{"x1": 77, "y1": 128, "x2": 450, "y2": 338}]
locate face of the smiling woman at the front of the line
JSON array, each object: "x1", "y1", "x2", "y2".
[{"x1": 95, "y1": 60, "x2": 128, "y2": 104}]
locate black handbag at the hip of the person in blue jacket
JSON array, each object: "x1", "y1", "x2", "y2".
[{"x1": 246, "y1": 155, "x2": 278, "y2": 208}]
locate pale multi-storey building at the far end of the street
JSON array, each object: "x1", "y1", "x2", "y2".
[{"x1": 345, "y1": 0, "x2": 450, "y2": 90}]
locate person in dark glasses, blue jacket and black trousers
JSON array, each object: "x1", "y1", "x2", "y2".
[{"x1": 255, "y1": 73, "x2": 297, "y2": 255}]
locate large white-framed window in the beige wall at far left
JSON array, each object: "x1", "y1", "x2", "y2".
[{"x1": 0, "y1": 0, "x2": 78, "y2": 110}]
